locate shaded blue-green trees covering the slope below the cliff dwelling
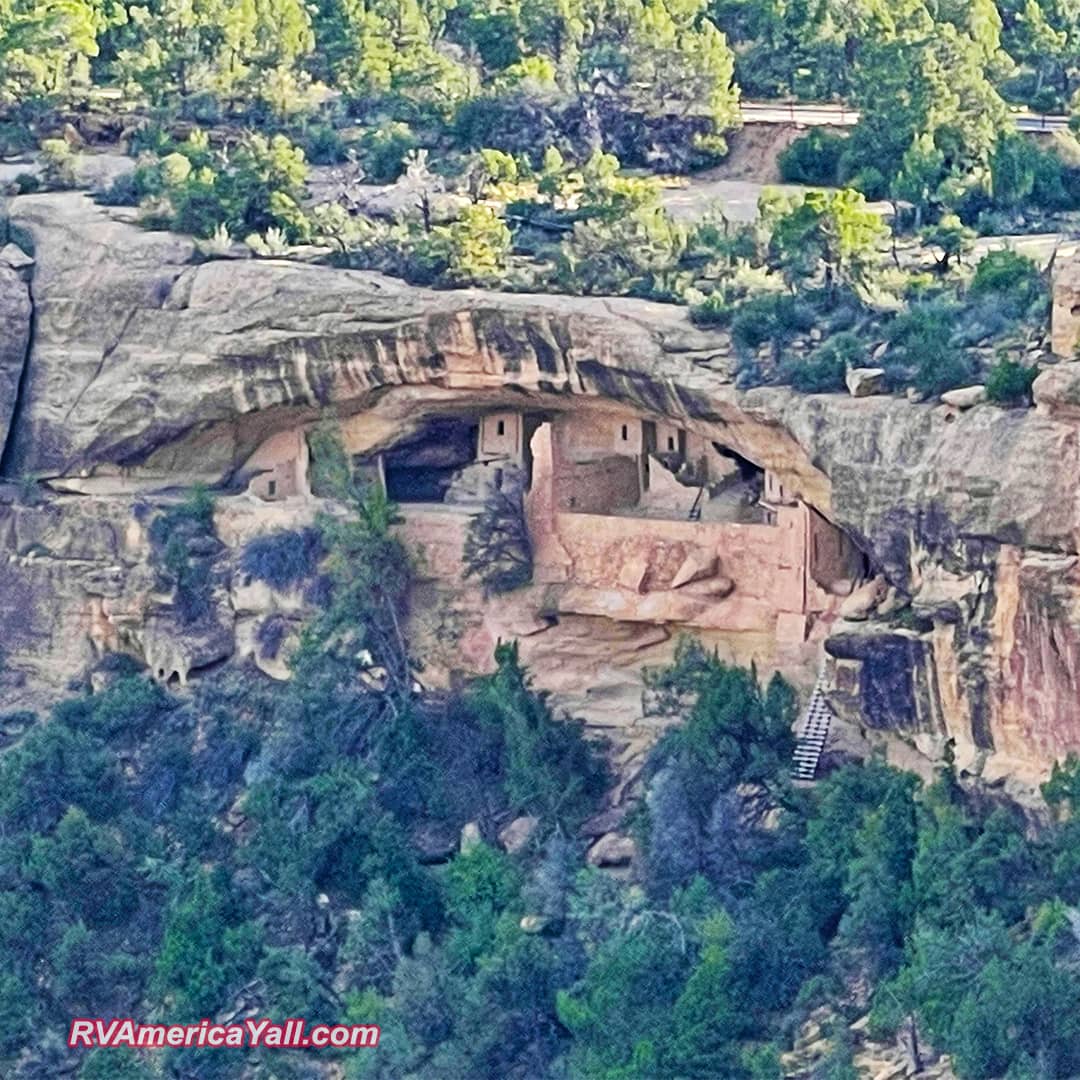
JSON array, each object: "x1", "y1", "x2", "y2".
[{"x1": 6, "y1": 570, "x2": 1080, "y2": 1080}]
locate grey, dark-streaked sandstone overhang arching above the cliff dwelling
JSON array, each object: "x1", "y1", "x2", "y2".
[{"x1": 9, "y1": 201, "x2": 1080, "y2": 580}]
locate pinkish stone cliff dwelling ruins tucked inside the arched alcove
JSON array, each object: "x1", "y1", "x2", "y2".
[{"x1": 236, "y1": 407, "x2": 867, "y2": 680}]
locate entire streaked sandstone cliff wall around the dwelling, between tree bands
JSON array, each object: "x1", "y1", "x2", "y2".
[{"x1": 0, "y1": 193, "x2": 1080, "y2": 799}]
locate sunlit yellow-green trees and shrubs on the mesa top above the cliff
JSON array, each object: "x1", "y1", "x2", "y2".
[{"x1": 0, "y1": 0, "x2": 1062, "y2": 403}]
